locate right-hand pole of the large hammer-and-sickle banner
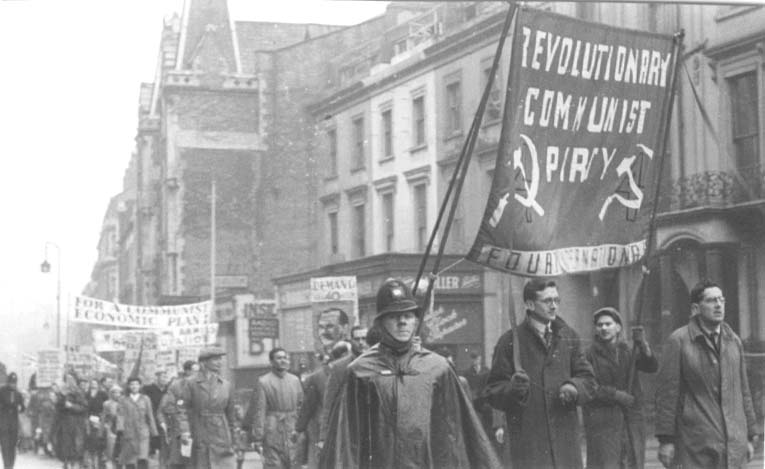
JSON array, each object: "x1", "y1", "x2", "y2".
[{"x1": 627, "y1": 29, "x2": 685, "y2": 393}]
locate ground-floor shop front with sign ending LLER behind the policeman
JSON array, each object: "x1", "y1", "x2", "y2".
[{"x1": 274, "y1": 254, "x2": 493, "y2": 372}]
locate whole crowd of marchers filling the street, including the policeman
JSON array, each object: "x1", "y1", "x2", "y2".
[{"x1": 0, "y1": 279, "x2": 761, "y2": 469}]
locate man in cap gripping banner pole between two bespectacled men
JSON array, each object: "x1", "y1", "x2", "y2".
[{"x1": 582, "y1": 307, "x2": 659, "y2": 468}]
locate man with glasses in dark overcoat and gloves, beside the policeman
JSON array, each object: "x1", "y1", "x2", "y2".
[{"x1": 483, "y1": 279, "x2": 594, "y2": 468}]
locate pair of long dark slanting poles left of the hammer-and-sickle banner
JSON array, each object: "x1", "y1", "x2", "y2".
[{"x1": 412, "y1": 2, "x2": 518, "y2": 335}]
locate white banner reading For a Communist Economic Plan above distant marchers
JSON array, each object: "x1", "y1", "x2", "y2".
[{"x1": 70, "y1": 296, "x2": 212, "y2": 329}]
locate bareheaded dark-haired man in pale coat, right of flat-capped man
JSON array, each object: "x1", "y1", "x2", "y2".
[{"x1": 252, "y1": 347, "x2": 303, "y2": 469}]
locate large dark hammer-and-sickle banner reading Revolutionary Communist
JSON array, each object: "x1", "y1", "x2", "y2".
[{"x1": 467, "y1": 8, "x2": 674, "y2": 276}]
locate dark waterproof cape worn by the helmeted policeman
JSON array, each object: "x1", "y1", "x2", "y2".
[{"x1": 320, "y1": 344, "x2": 500, "y2": 469}]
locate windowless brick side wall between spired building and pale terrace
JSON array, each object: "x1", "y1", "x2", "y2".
[{"x1": 260, "y1": 18, "x2": 389, "y2": 288}]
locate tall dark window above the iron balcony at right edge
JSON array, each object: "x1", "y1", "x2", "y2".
[{"x1": 727, "y1": 71, "x2": 760, "y2": 175}]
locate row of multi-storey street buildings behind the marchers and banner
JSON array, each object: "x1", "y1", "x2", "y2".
[{"x1": 85, "y1": 0, "x2": 765, "y2": 400}]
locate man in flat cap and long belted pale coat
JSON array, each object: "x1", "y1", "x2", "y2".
[{"x1": 176, "y1": 346, "x2": 236, "y2": 469}]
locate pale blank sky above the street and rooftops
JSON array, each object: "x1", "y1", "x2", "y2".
[{"x1": 0, "y1": 0, "x2": 388, "y2": 372}]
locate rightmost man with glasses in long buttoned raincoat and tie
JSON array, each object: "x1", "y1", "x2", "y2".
[{"x1": 656, "y1": 281, "x2": 758, "y2": 468}]
